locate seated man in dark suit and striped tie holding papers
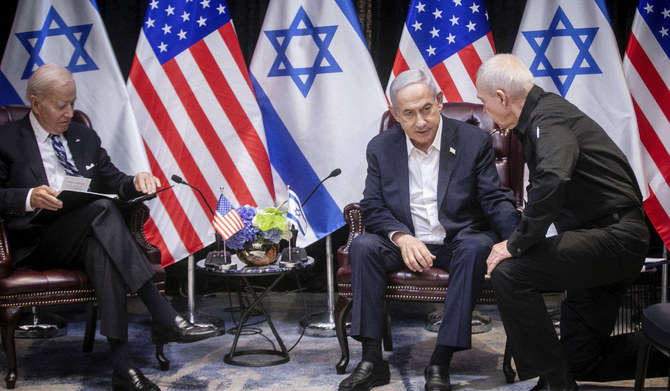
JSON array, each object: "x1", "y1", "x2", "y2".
[{"x1": 0, "y1": 65, "x2": 216, "y2": 390}]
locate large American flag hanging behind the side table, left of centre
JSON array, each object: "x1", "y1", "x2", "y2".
[{"x1": 128, "y1": 0, "x2": 275, "y2": 265}]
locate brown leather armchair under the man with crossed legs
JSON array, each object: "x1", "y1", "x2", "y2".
[{"x1": 0, "y1": 105, "x2": 169, "y2": 389}]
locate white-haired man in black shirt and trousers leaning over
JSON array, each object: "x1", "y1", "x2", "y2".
[{"x1": 477, "y1": 54, "x2": 649, "y2": 390}]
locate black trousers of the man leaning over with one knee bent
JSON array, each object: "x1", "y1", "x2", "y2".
[{"x1": 491, "y1": 210, "x2": 649, "y2": 380}]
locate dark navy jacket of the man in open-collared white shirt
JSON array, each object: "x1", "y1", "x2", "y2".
[{"x1": 360, "y1": 117, "x2": 519, "y2": 244}]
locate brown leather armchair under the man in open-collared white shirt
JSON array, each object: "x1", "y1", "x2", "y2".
[{"x1": 335, "y1": 102, "x2": 524, "y2": 381}]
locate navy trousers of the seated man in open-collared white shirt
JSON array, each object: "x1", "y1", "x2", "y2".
[{"x1": 349, "y1": 232, "x2": 496, "y2": 350}]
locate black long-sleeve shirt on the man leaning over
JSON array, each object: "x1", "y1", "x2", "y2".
[{"x1": 507, "y1": 86, "x2": 642, "y2": 256}]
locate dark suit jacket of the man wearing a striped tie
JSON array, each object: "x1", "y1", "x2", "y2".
[{"x1": 0, "y1": 115, "x2": 140, "y2": 262}]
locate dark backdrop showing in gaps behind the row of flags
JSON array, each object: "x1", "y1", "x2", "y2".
[{"x1": 0, "y1": 0, "x2": 656, "y2": 290}]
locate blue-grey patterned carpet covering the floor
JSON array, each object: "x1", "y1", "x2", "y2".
[{"x1": 0, "y1": 292, "x2": 665, "y2": 391}]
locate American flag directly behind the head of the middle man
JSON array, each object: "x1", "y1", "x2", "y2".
[{"x1": 386, "y1": 0, "x2": 495, "y2": 102}]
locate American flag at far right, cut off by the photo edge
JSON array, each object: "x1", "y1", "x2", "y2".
[{"x1": 624, "y1": 0, "x2": 670, "y2": 246}]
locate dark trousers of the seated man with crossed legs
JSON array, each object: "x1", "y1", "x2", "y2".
[{"x1": 21, "y1": 200, "x2": 154, "y2": 341}]
